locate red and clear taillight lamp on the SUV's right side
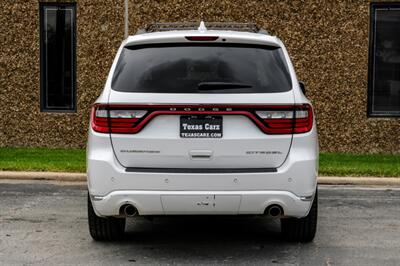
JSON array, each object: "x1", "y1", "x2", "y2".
[{"x1": 256, "y1": 104, "x2": 313, "y2": 134}]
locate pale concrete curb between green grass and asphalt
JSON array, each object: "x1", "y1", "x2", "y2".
[{"x1": 0, "y1": 171, "x2": 400, "y2": 187}]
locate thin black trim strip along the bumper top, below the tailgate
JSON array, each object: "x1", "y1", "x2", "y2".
[{"x1": 125, "y1": 167, "x2": 278, "y2": 174}]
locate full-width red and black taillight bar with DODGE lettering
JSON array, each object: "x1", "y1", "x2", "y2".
[{"x1": 92, "y1": 104, "x2": 313, "y2": 134}]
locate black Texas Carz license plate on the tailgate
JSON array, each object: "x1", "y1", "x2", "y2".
[{"x1": 180, "y1": 116, "x2": 222, "y2": 138}]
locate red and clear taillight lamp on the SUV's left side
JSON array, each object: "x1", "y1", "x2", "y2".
[{"x1": 92, "y1": 104, "x2": 147, "y2": 133}]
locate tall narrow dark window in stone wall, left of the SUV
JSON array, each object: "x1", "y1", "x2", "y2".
[{"x1": 40, "y1": 3, "x2": 76, "y2": 112}]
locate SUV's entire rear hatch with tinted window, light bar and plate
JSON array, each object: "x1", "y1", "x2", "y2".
[{"x1": 103, "y1": 43, "x2": 295, "y2": 169}]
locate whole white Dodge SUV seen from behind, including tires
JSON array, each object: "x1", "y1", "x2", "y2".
[{"x1": 87, "y1": 23, "x2": 318, "y2": 241}]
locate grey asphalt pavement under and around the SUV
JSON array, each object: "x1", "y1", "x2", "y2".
[{"x1": 0, "y1": 180, "x2": 400, "y2": 265}]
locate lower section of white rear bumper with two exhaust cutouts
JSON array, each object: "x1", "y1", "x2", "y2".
[{"x1": 92, "y1": 190, "x2": 312, "y2": 217}]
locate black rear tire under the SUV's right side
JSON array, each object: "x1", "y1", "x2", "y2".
[{"x1": 281, "y1": 188, "x2": 318, "y2": 242}]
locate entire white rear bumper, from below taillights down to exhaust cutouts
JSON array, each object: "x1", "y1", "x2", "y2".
[{"x1": 87, "y1": 123, "x2": 318, "y2": 217}]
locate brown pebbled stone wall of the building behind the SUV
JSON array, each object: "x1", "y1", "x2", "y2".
[{"x1": 0, "y1": 0, "x2": 400, "y2": 153}]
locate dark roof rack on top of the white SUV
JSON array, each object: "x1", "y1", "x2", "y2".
[{"x1": 141, "y1": 22, "x2": 268, "y2": 35}]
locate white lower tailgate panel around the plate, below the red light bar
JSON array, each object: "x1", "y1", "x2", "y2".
[{"x1": 111, "y1": 115, "x2": 292, "y2": 168}]
